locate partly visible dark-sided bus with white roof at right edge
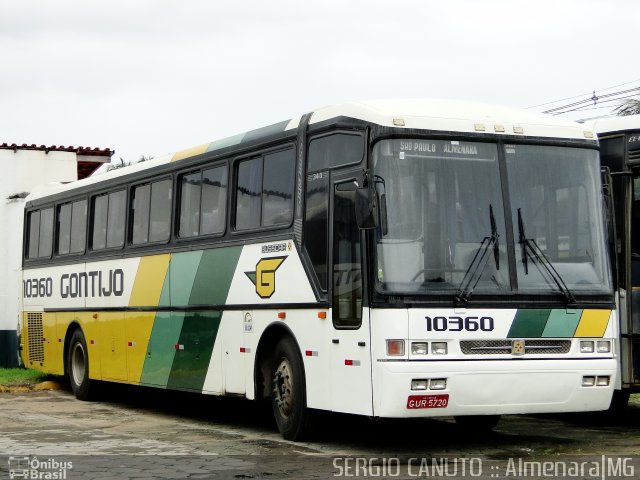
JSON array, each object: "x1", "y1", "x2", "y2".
[{"x1": 588, "y1": 115, "x2": 640, "y2": 408}]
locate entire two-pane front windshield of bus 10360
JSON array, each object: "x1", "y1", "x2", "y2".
[{"x1": 373, "y1": 139, "x2": 610, "y2": 296}]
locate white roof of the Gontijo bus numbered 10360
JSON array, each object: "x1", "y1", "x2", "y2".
[{"x1": 27, "y1": 99, "x2": 593, "y2": 201}]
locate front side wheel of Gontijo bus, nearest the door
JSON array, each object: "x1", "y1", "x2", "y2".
[{"x1": 270, "y1": 337, "x2": 311, "y2": 440}]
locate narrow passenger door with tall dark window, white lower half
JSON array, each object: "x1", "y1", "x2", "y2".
[{"x1": 329, "y1": 171, "x2": 373, "y2": 415}]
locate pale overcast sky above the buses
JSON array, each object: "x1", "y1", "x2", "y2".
[{"x1": 0, "y1": 0, "x2": 640, "y2": 162}]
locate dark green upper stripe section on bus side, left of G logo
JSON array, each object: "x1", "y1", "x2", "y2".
[{"x1": 189, "y1": 247, "x2": 242, "y2": 305}]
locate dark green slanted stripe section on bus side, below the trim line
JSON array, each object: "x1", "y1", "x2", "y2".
[{"x1": 167, "y1": 312, "x2": 221, "y2": 392}]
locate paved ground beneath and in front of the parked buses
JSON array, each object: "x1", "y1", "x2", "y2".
[{"x1": 0, "y1": 386, "x2": 640, "y2": 480}]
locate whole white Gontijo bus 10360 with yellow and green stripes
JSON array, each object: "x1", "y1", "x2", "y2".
[{"x1": 21, "y1": 100, "x2": 618, "y2": 440}]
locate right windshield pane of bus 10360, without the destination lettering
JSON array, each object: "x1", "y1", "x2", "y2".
[{"x1": 505, "y1": 145, "x2": 611, "y2": 293}]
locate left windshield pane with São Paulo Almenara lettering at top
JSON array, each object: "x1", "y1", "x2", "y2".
[{"x1": 373, "y1": 139, "x2": 509, "y2": 295}]
